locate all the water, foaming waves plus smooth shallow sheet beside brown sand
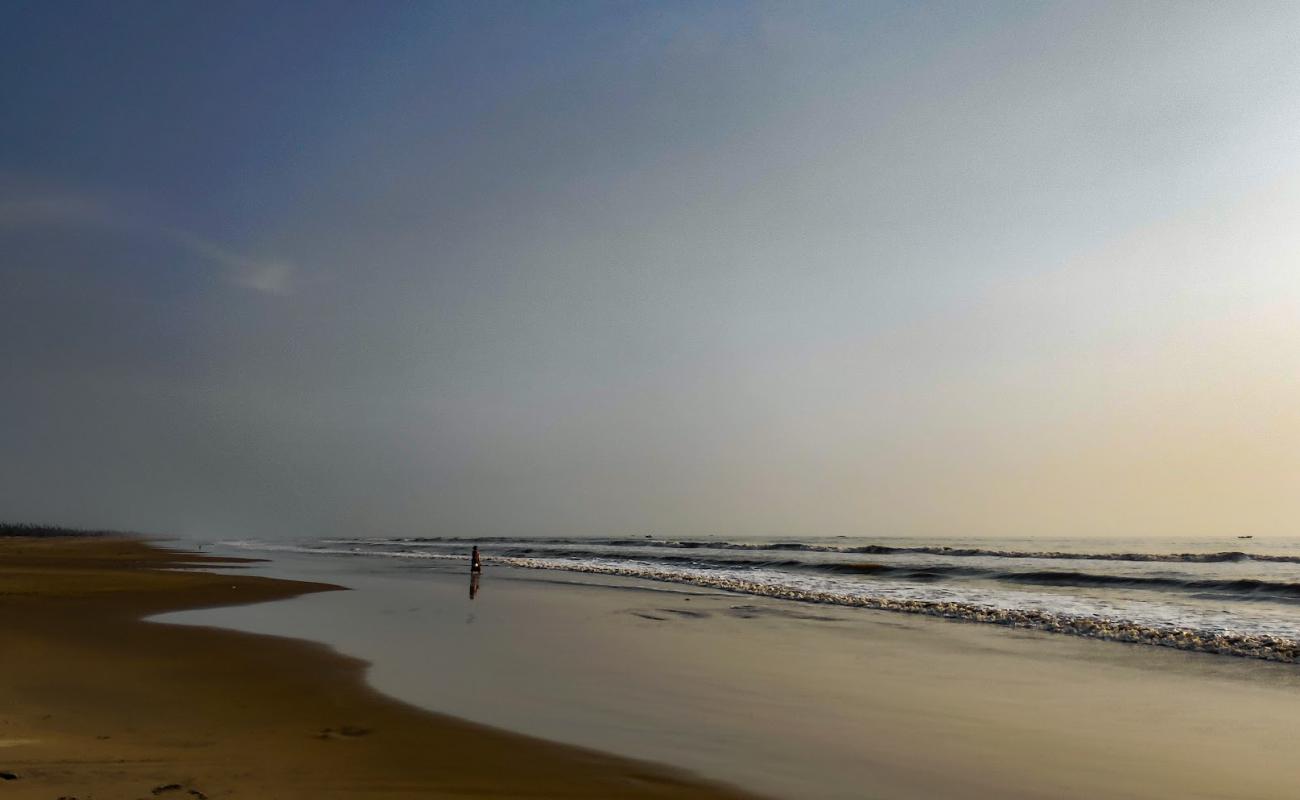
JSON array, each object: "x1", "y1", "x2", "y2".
[{"x1": 159, "y1": 536, "x2": 1300, "y2": 800}]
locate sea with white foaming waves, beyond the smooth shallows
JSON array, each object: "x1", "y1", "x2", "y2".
[{"x1": 222, "y1": 536, "x2": 1300, "y2": 662}]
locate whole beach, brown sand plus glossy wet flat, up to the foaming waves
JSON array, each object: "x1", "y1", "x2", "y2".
[{"x1": 0, "y1": 537, "x2": 1300, "y2": 800}]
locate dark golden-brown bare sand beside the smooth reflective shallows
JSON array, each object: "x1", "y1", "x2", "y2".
[{"x1": 0, "y1": 539, "x2": 744, "y2": 800}]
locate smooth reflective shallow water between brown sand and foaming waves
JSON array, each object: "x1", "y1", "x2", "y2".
[{"x1": 159, "y1": 545, "x2": 1300, "y2": 799}]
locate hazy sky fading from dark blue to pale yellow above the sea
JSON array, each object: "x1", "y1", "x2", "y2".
[{"x1": 0, "y1": 0, "x2": 1300, "y2": 537}]
